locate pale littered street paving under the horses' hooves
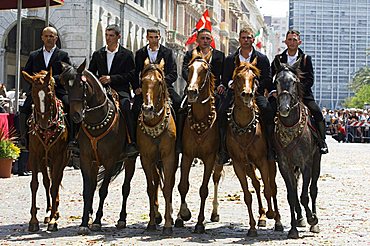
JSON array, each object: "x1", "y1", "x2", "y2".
[{"x1": 0, "y1": 137, "x2": 370, "y2": 245}]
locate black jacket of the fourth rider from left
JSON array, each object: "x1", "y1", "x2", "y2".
[{"x1": 182, "y1": 47, "x2": 225, "y2": 87}]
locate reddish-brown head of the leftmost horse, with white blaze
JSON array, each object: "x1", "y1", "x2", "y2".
[{"x1": 22, "y1": 68, "x2": 57, "y2": 129}]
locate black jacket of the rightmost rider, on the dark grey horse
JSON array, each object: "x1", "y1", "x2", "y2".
[{"x1": 271, "y1": 49, "x2": 314, "y2": 100}]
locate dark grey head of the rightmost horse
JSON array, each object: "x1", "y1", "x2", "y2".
[{"x1": 274, "y1": 59, "x2": 302, "y2": 117}]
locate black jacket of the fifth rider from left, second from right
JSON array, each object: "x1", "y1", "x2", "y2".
[{"x1": 222, "y1": 48, "x2": 275, "y2": 95}]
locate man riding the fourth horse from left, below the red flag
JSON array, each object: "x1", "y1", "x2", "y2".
[{"x1": 176, "y1": 28, "x2": 229, "y2": 160}]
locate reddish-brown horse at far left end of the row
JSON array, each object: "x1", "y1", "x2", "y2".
[{"x1": 22, "y1": 69, "x2": 68, "y2": 232}]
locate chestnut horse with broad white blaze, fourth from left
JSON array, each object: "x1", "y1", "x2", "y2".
[{"x1": 175, "y1": 50, "x2": 219, "y2": 233}]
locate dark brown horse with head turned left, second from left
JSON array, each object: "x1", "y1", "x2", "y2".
[{"x1": 60, "y1": 61, "x2": 136, "y2": 235}]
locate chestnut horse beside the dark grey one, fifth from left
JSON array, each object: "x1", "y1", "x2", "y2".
[{"x1": 214, "y1": 57, "x2": 283, "y2": 236}]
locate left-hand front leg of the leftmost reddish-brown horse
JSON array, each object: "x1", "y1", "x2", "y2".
[{"x1": 28, "y1": 157, "x2": 40, "y2": 232}]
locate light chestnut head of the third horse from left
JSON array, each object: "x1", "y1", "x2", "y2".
[{"x1": 141, "y1": 58, "x2": 168, "y2": 120}]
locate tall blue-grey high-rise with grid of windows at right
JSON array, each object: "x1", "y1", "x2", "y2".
[{"x1": 289, "y1": 0, "x2": 370, "y2": 108}]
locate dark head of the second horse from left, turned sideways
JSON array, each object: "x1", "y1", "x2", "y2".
[{"x1": 60, "y1": 60, "x2": 88, "y2": 123}]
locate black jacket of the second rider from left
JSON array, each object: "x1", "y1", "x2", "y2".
[{"x1": 89, "y1": 45, "x2": 139, "y2": 96}]
